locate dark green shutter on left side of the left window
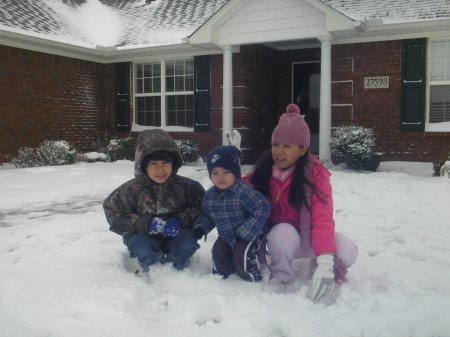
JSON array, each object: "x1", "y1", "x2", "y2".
[{"x1": 116, "y1": 63, "x2": 130, "y2": 131}]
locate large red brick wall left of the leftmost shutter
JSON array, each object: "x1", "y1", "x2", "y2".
[{"x1": 0, "y1": 46, "x2": 115, "y2": 156}]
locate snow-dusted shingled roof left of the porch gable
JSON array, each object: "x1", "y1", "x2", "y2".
[{"x1": 0, "y1": 0, "x2": 228, "y2": 47}]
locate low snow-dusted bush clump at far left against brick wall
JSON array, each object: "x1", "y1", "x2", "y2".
[{"x1": 11, "y1": 140, "x2": 77, "y2": 167}]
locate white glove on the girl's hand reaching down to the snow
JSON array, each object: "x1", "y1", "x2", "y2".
[{"x1": 312, "y1": 254, "x2": 334, "y2": 301}]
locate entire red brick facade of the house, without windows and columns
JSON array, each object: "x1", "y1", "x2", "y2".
[{"x1": 0, "y1": 41, "x2": 450, "y2": 163}]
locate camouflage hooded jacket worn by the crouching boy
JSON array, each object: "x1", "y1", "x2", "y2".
[{"x1": 103, "y1": 130, "x2": 205, "y2": 236}]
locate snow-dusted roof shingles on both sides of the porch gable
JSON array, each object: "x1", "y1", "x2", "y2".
[{"x1": 0, "y1": 0, "x2": 450, "y2": 48}]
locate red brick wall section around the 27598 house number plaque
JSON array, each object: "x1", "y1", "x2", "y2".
[{"x1": 331, "y1": 41, "x2": 450, "y2": 161}]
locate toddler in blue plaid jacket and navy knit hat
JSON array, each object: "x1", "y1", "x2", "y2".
[{"x1": 194, "y1": 146, "x2": 270, "y2": 282}]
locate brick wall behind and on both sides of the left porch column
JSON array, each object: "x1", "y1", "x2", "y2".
[{"x1": 175, "y1": 46, "x2": 277, "y2": 163}]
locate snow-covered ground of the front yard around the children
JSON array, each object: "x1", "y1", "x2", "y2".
[{"x1": 0, "y1": 161, "x2": 450, "y2": 337}]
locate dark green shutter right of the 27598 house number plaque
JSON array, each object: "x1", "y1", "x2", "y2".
[{"x1": 400, "y1": 39, "x2": 426, "y2": 131}]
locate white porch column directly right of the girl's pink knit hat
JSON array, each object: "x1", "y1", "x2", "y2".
[{"x1": 318, "y1": 36, "x2": 332, "y2": 161}]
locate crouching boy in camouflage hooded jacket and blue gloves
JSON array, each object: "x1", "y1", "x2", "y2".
[{"x1": 103, "y1": 129, "x2": 205, "y2": 270}]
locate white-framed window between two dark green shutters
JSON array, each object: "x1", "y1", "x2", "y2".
[{"x1": 134, "y1": 59, "x2": 194, "y2": 128}]
